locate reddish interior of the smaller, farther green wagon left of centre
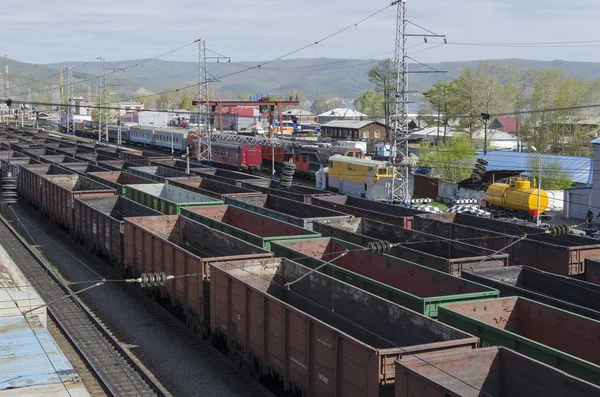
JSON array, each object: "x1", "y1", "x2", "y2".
[{"x1": 188, "y1": 205, "x2": 318, "y2": 237}]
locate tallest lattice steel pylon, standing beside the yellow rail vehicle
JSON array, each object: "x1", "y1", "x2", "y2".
[{"x1": 388, "y1": 0, "x2": 410, "y2": 203}]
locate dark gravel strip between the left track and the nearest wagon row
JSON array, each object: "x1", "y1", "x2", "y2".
[{"x1": 13, "y1": 206, "x2": 253, "y2": 397}]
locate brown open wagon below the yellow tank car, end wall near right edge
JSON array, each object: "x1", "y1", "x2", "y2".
[{"x1": 415, "y1": 213, "x2": 600, "y2": 276}]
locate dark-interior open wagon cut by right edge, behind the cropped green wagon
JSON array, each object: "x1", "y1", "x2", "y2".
[{"x1": 463, "y1": 261, "x2": 600, "y2": 320}]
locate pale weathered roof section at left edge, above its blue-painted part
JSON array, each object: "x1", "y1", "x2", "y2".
[{"x1": 0, "y1": 241, "x2": 46, "y2": 327}]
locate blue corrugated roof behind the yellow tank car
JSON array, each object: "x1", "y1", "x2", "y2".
[{"x1": 477, "y1": 151, "x2": 600, "y2": 185}]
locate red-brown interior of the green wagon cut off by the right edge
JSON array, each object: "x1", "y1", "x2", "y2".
[{"x1": 444, "y1": 297, "x2": 600, "y2": 364}]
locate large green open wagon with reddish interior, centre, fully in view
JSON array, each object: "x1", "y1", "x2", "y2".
[{"x1": 271, "y1": 238, "x2": 499, "y2": 318}]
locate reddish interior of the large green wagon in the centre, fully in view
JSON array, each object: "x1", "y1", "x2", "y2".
[{"x1": 278, "y1": 238, "x2": 489, "y2": 298}]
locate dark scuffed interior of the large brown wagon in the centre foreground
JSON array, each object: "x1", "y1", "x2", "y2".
[{"x1": 216, "y1": 258, "x2": 469, "y2": 349}]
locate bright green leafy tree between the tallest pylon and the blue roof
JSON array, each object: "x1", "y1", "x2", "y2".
[{"x1": 419, "y1": 136, "x2": 476, "y2": 182}]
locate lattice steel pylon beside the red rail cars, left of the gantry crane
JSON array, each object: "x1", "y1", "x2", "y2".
[{"x1": 197, "y1": 39, "x2": 212, "y2": 165}]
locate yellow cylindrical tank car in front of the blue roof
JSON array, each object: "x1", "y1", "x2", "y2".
[{"x1": 485, "y1": 177, "x2": 548, "y2": 216}]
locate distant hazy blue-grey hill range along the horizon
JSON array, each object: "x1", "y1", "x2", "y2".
[{"x1": 3, "y1": 58, "x2": 600, "y2": 102}]
